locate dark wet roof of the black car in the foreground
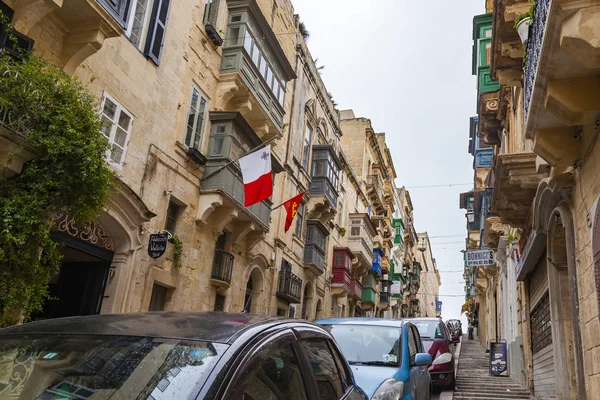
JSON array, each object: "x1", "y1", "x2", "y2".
[{"x1": 0, "y1": 312, "x2": 299, "y2": 343}]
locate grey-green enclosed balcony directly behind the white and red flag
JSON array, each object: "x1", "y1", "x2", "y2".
[{"x1": 196, "y1": 112, "x2": 283, "y2": 248}]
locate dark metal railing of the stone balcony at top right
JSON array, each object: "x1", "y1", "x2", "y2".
[{"x1": 523, "y1": 0, "x2": 550, "y2": 122}]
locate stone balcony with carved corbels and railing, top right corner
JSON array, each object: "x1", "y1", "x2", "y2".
[{"x1": 524, "y1": 0, "x2": 600, "y2": 170}]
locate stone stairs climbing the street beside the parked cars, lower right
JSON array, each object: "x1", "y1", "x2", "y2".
[{"x1": 453, "y1": 335, "x2": 531, "y2": 400}]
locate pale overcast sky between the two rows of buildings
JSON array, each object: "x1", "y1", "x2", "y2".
[{"x1": 292, "y1": 0, "x2": 485, "y2": 323}]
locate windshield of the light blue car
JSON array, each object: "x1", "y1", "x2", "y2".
[{"x1": 325, "y1": 325, "x2": 401, "y2": 366}]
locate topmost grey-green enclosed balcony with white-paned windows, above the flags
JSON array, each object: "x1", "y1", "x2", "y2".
[{"x1": 214, "y1": 0, "x2": 296, "y2": 140}]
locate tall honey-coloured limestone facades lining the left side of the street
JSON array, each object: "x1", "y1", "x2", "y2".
[{"x1": 0, "y1": 0, "x2": 414, "y2": 320}]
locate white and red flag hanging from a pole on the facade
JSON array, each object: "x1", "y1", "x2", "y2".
[{"x1": 239, "y1": 145, "x2": 273, "y2": 207}]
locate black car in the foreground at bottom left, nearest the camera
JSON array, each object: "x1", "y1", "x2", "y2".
[{"x1": 0, "y1": 312, "x2": 367, "y2": 400}]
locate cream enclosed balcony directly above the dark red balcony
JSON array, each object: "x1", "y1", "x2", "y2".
[{"x1": 348, "y1": 214, "x2": 376, "y2": 276}]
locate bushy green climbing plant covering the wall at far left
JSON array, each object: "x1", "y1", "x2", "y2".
[{"x1": 0, "y1": 56, "x2": 114, "y2": 326}]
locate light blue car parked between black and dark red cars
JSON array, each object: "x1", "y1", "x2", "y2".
[{"x1": 317, "y1": 318, "x2": 432, "y2": 400}]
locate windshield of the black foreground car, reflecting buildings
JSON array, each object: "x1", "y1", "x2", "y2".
[{"x1": 0, "y1": 335, "x2": 228, "y2": 400}]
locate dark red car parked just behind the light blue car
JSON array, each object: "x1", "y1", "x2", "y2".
[{"x1": 410, "y1": 318, "x2": 458, "y2": 389}]
